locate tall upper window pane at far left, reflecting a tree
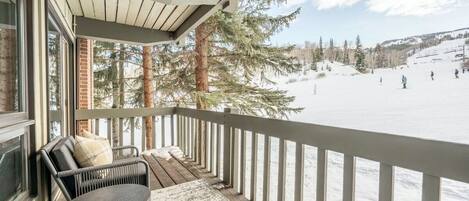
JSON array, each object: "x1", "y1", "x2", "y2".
[{"x1": 0, "y1": 0, "x2": 19, "y2": 114}]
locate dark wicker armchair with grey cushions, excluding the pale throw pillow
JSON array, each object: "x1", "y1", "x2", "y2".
[{"x1": 39, "y1": 137, "x2": 149, "y2": 200}]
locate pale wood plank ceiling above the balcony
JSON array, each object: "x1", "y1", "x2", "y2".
[{"x1": 67, "y1": 0, "x2": 199, "y2": 32}]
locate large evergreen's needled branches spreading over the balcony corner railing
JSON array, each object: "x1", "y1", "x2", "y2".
[{"x1": 155, "y1": 0, "x2": 301, "y2": 117}]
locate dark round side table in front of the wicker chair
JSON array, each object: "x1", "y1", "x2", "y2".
[{"x1": 73, "y1": 184, "x2": 150, "y2": 201}]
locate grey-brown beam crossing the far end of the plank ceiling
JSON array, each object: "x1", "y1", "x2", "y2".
[{"x1": 76, "y1": 17, "x2": 174, "y2": 45}]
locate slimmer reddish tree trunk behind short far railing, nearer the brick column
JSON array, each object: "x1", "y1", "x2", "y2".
[{"x1": 143, "y1": 46, "x2": 153, "y2": 149}]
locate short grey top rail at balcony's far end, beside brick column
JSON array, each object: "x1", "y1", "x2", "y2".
[{"x1": 75, "y1": 107, "x2": 175, "y2": 120}]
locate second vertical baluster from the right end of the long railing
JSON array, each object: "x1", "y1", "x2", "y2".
[{"x1": 379, "y1": 163, "x2": 394, "y2": 201}]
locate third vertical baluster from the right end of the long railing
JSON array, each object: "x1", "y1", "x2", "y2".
[{"x1": 342, "y1": 154, "x2": 355, "y2": 201}]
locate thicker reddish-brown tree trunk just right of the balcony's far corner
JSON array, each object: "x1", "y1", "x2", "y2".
[{"x1": 195, "y1": 23, "x2": 210, "y2": 165}]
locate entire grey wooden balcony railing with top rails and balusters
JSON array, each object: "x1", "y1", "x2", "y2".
[{"x1": 76, "y1": 108, "x2": 469, "y2": 201}]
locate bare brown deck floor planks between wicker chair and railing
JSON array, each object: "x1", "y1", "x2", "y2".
[{"x1": 142, "y1": 150, "x2": 247, "y2": 201}]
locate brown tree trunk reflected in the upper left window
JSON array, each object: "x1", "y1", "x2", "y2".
[{"x1": 0, "y1": 29, "x2": 17, "y2": 112}]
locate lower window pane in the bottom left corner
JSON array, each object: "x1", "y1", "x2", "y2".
[{"x1": 0, "y1": 137, "x2": 24, "y2": 201}]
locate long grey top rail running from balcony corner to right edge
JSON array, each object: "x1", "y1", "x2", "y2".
[{"x1": 176, "y1": 108, "x2": 469, "y2": 183}]
